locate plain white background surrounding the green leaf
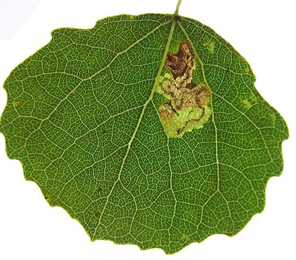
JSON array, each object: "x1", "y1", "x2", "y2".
[{"x1": 0, "y1": 0, "x2": 296, "y2": 260}]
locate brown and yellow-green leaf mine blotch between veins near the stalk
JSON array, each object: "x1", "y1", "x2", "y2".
[{"x1": 156, "y1": 41, "x2": 211, "y2": 138}]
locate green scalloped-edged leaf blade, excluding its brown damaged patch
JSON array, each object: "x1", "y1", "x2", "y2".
[{"x1": 0, "y1": 14, "x2": 288, "y2": 254}]
